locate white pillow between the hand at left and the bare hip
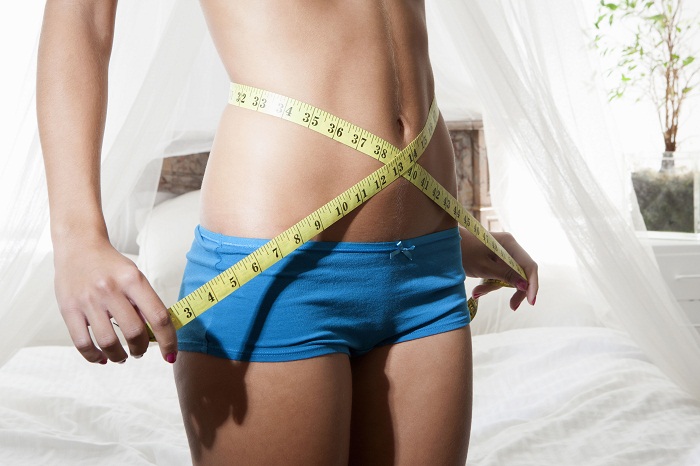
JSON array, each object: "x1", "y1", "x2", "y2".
[{"x1": 136, "y1": 190, "x2": 201, "y2": 306}]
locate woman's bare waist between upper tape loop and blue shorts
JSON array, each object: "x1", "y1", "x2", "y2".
[{"x1": 200, "y1": 88, "x2": 456, "y2": 241}]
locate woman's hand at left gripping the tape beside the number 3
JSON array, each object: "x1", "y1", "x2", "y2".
[{"x1": 54, "y1": 237, "x2": 177, "y2": 364}]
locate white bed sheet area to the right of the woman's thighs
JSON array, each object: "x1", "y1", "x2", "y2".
[{"x1": 469, "y1": 327, "x2": 700, "y2": 466}]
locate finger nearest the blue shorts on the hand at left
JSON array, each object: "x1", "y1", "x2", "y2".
[{"x1": 127, "y1": 273, "x2": 177, "y2": 364}]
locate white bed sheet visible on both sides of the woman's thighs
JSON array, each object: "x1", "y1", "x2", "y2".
[{"x1": 0, "y1": 327, "x2": 700, "y2": 466}]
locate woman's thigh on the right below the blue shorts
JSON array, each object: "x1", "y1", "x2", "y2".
[{"x1": 350, "y1": 326, "x2": 472, "y2": 465}]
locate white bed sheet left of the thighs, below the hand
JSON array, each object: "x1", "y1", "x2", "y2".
[{"x1": 0, "y1": 346, "x2": 191, "y2": 466}]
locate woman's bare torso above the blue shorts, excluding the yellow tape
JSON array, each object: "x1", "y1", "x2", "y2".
[{"x1": 200, "y1": 0, "x2": 456, "y2": 241}]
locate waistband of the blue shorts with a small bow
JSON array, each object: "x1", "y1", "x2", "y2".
[{"x1": 195, "y1": 225, "x2": 460, "y2": 252}]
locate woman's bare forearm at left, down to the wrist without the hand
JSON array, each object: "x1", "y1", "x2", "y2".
[{"x1": 37, "y1": 0, "x2": 116, "y2": 246}]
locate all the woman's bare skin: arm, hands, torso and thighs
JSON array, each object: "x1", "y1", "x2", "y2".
[{"x1": 37, "y1": 0, "x2": 538, "y2": 465}]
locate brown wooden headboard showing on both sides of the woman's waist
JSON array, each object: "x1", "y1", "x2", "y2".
[{"x1": 158, "y1": 120, "x2": 500, "y2": 231}]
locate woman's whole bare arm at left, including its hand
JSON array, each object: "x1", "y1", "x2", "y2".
[{"x1": 36, "y1": 0, "x2": 177, "y2": 363}]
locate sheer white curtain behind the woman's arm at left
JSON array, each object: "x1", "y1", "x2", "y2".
[{"x1": 0, "y1": 0, "x2": 213, "y2": 364}]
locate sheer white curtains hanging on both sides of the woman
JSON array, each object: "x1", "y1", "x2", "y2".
[{"x1": 0, "y1": 0, "x2": 700, "y2": 398}]
